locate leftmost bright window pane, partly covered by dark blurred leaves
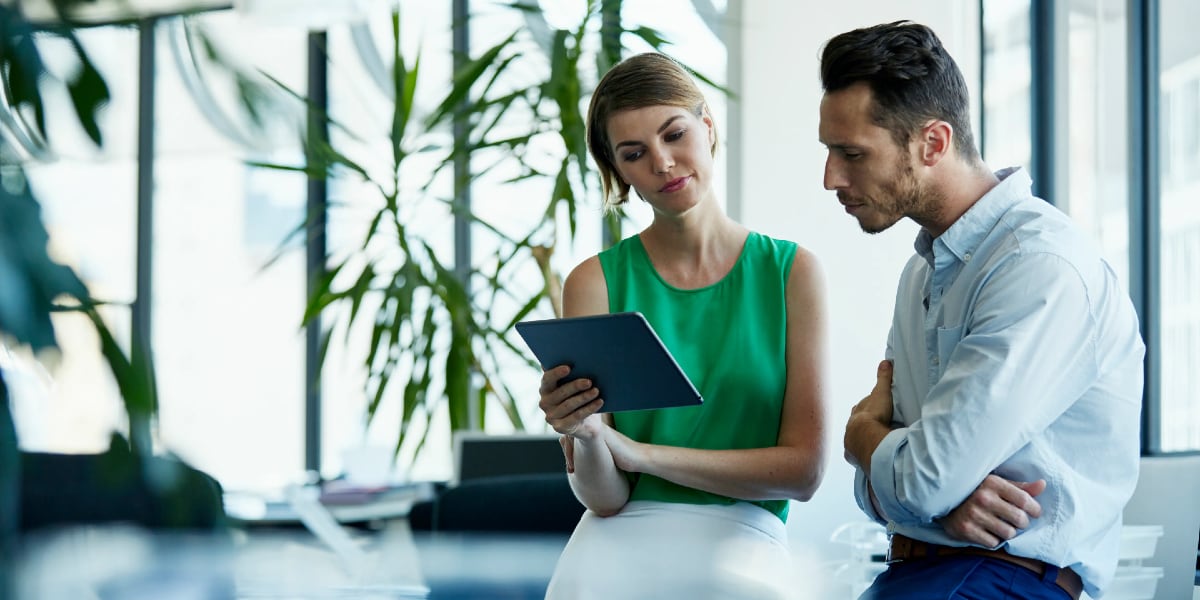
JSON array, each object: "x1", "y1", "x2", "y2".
[{"x1": 14, "y1": 28, "x2": 138, "y2": 452}]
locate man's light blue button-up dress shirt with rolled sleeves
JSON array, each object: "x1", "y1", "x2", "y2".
[{"x1": 856, "y1": 169, "x2": 1145, "y2": 596}]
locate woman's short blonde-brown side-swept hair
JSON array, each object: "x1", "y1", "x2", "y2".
[{"x1": 588, "y1": 52, "x2": 716, "y2": 209}]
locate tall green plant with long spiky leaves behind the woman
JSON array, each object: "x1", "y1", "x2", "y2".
[{"x1": 246, "y1": 0, "x2": 710, "y2": 470}]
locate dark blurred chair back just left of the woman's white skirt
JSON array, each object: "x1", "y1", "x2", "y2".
[{"x1": 408, "y1": 472, "x2": 583, "y2": 534}]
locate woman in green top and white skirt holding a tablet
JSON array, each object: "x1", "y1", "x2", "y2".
[{"x1": 540, "y1": 53, "x2": 826, "y2": 599}]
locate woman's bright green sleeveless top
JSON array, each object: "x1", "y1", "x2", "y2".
[{"x1": 600, "y1": 233, "x2": 796, "y2": 522}]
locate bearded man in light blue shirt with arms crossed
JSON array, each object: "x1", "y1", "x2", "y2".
[{"x1": 820, "y1": 22, "x2": 1145, "y2": 600}]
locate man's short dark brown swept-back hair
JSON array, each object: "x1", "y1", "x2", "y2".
[{"x1": 821, "y1": 20, "x2": 979, "y2": 161}]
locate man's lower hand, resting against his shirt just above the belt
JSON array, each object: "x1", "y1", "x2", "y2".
[{"x1": 941, "y1": 475, "x2": 1046, "y2": 548}]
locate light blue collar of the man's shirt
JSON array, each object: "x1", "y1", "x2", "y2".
[{"x1": 913, "y1": 167, "x2": 1033, "y2": 265}]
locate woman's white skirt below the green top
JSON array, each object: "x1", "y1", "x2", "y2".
[{"x1": 546, "y1": 500, "x2": 808, "y2": 600}]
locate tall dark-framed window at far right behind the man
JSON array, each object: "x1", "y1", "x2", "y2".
[{"x1": 983, "y1": 0, "x2": 1200, "y2": 452}]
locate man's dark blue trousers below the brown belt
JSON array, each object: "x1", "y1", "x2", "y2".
[{"x1": 858, "y1": 556, "x2": 1070, "y2": 600}]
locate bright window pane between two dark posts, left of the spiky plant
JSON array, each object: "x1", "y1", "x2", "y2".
[{"x1": 151, "y1": 11, "x2": 307, "y2": 490}]
